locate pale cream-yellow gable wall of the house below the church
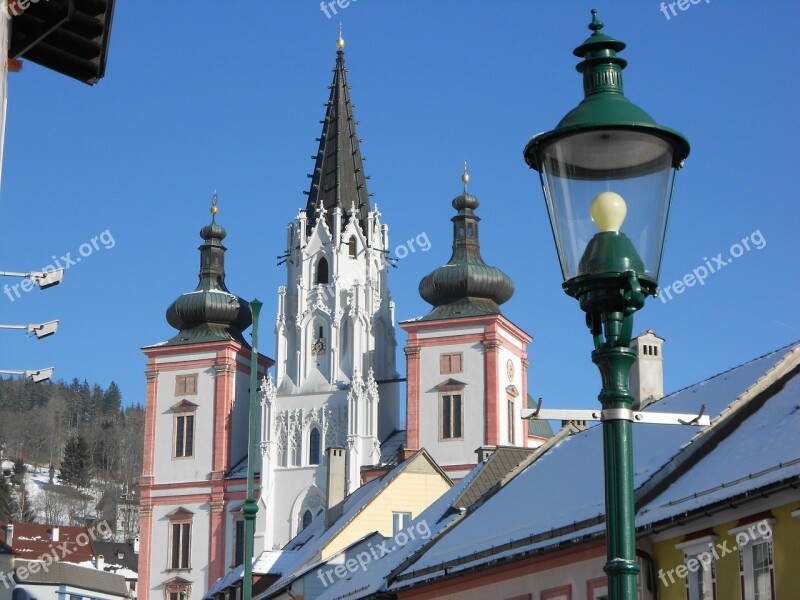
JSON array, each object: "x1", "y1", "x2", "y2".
[{"x1": 322, "y1": 464, "x2": 450, "y2": 559}]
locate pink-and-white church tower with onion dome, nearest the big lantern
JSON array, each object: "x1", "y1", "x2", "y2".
[{"x1": 400, "y1": 168, "x2": 543, "y2": 479}]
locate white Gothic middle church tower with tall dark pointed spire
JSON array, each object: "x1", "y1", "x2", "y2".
[{"x1": 262, "y1": 31, "x2": 399, "y2": 550}]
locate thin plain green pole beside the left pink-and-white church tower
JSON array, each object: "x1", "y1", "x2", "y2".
[{"x1": 242, "y1": 298, "x2": 263, "y2": 600}]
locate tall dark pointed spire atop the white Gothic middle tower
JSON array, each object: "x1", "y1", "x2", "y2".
[{"x1": 306, "y1": 31, "x2": 369, "y2": 233}]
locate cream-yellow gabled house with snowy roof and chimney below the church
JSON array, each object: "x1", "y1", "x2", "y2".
[{"x1": 206, "y1": 448, "x2": 453, "y2": 599}]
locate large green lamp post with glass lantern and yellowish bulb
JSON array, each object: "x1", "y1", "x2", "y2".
[{"x1": 524, "y1": 10, "x2": 689, "y2": 600}]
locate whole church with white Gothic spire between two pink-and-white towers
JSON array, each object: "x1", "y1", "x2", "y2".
[{"x1": 138, "y1": 35, "x2": 549, "y2": 600}]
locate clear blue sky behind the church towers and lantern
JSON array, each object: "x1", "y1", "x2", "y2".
[{"x1": 0, "y1": 0, "x2": 800, "y2": 418}]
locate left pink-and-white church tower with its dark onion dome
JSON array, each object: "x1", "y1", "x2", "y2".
[{"x1": 139, "y1": 194, "x2": 272, "y2": 600}]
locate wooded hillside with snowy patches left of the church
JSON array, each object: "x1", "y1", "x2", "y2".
[{"x1": 0, "y1": 378, "x2": 144, "y2": 536}]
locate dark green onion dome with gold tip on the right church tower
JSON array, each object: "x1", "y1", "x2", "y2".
[{"x1": 419, "y1": 161, "x2": 514, "y2": 321}]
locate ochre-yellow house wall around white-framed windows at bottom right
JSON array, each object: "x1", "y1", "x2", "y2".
[{"x1": 653, "y1": 501, "x2": 800, "y2": 600}]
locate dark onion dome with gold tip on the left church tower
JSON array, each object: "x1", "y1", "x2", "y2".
[{"x1": 162, "y1": 192, "x2": 252, "y2": 346}]
